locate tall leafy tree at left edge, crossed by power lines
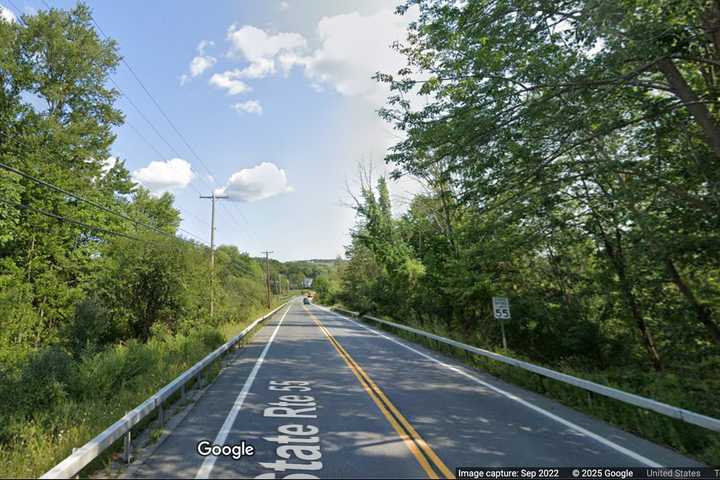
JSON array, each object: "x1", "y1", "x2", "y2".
[{"x1": 0, "y1": 4, "x2": 122, "y2": 346}]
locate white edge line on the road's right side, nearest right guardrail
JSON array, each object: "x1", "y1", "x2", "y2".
[{"x1": 316, "y1": 305, "x2": 663, "y2": 468}]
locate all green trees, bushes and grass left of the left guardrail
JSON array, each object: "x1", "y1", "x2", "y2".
[{"x1": 0, "y1": 4, "x2": 278, "y2": 477}]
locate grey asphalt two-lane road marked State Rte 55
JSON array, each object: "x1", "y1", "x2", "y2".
[{"x1": 128, "y1": 300, "x2": 698, "y2": 478}]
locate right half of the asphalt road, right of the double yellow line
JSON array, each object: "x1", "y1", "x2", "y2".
[{"x1": 313, "y1": 307, "x2": 700, "y2": 468}]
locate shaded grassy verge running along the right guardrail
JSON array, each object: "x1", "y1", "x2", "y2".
[{"x1": 330, "y1": 304, "x2": 720, "y2": 466}]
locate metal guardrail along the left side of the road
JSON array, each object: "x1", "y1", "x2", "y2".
[{"x1": 40, "y1": 302, "x2": 288, "y2": 478}]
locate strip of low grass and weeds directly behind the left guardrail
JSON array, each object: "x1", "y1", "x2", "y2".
[{"x1": 0, "y1": 298, "x2": 287, "y2": 478}]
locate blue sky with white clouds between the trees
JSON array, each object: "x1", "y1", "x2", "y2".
[{"x1": 0, "y1": 0, "x2": 418, "y2": 260}]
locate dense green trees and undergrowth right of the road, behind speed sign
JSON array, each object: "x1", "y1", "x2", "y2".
[{"x1": 337, "y1": 0, "x2": 720, "y2": 460}]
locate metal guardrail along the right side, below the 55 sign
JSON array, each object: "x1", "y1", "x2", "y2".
[{"x1": 333, "y1": 308, "x2": 720, "y2": 432}]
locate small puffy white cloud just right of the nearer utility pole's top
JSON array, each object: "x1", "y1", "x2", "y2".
[{"x1": 215, "y1": 162, "x2": 293, "y2": 202}]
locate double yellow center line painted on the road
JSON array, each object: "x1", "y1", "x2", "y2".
[{"x1": 303, "y1": 305, "x2": 455, "y2": 478}]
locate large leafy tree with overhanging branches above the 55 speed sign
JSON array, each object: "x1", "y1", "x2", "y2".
[{"x1": 366, "y1": 0, "x2": 720, "y2": 368}]
